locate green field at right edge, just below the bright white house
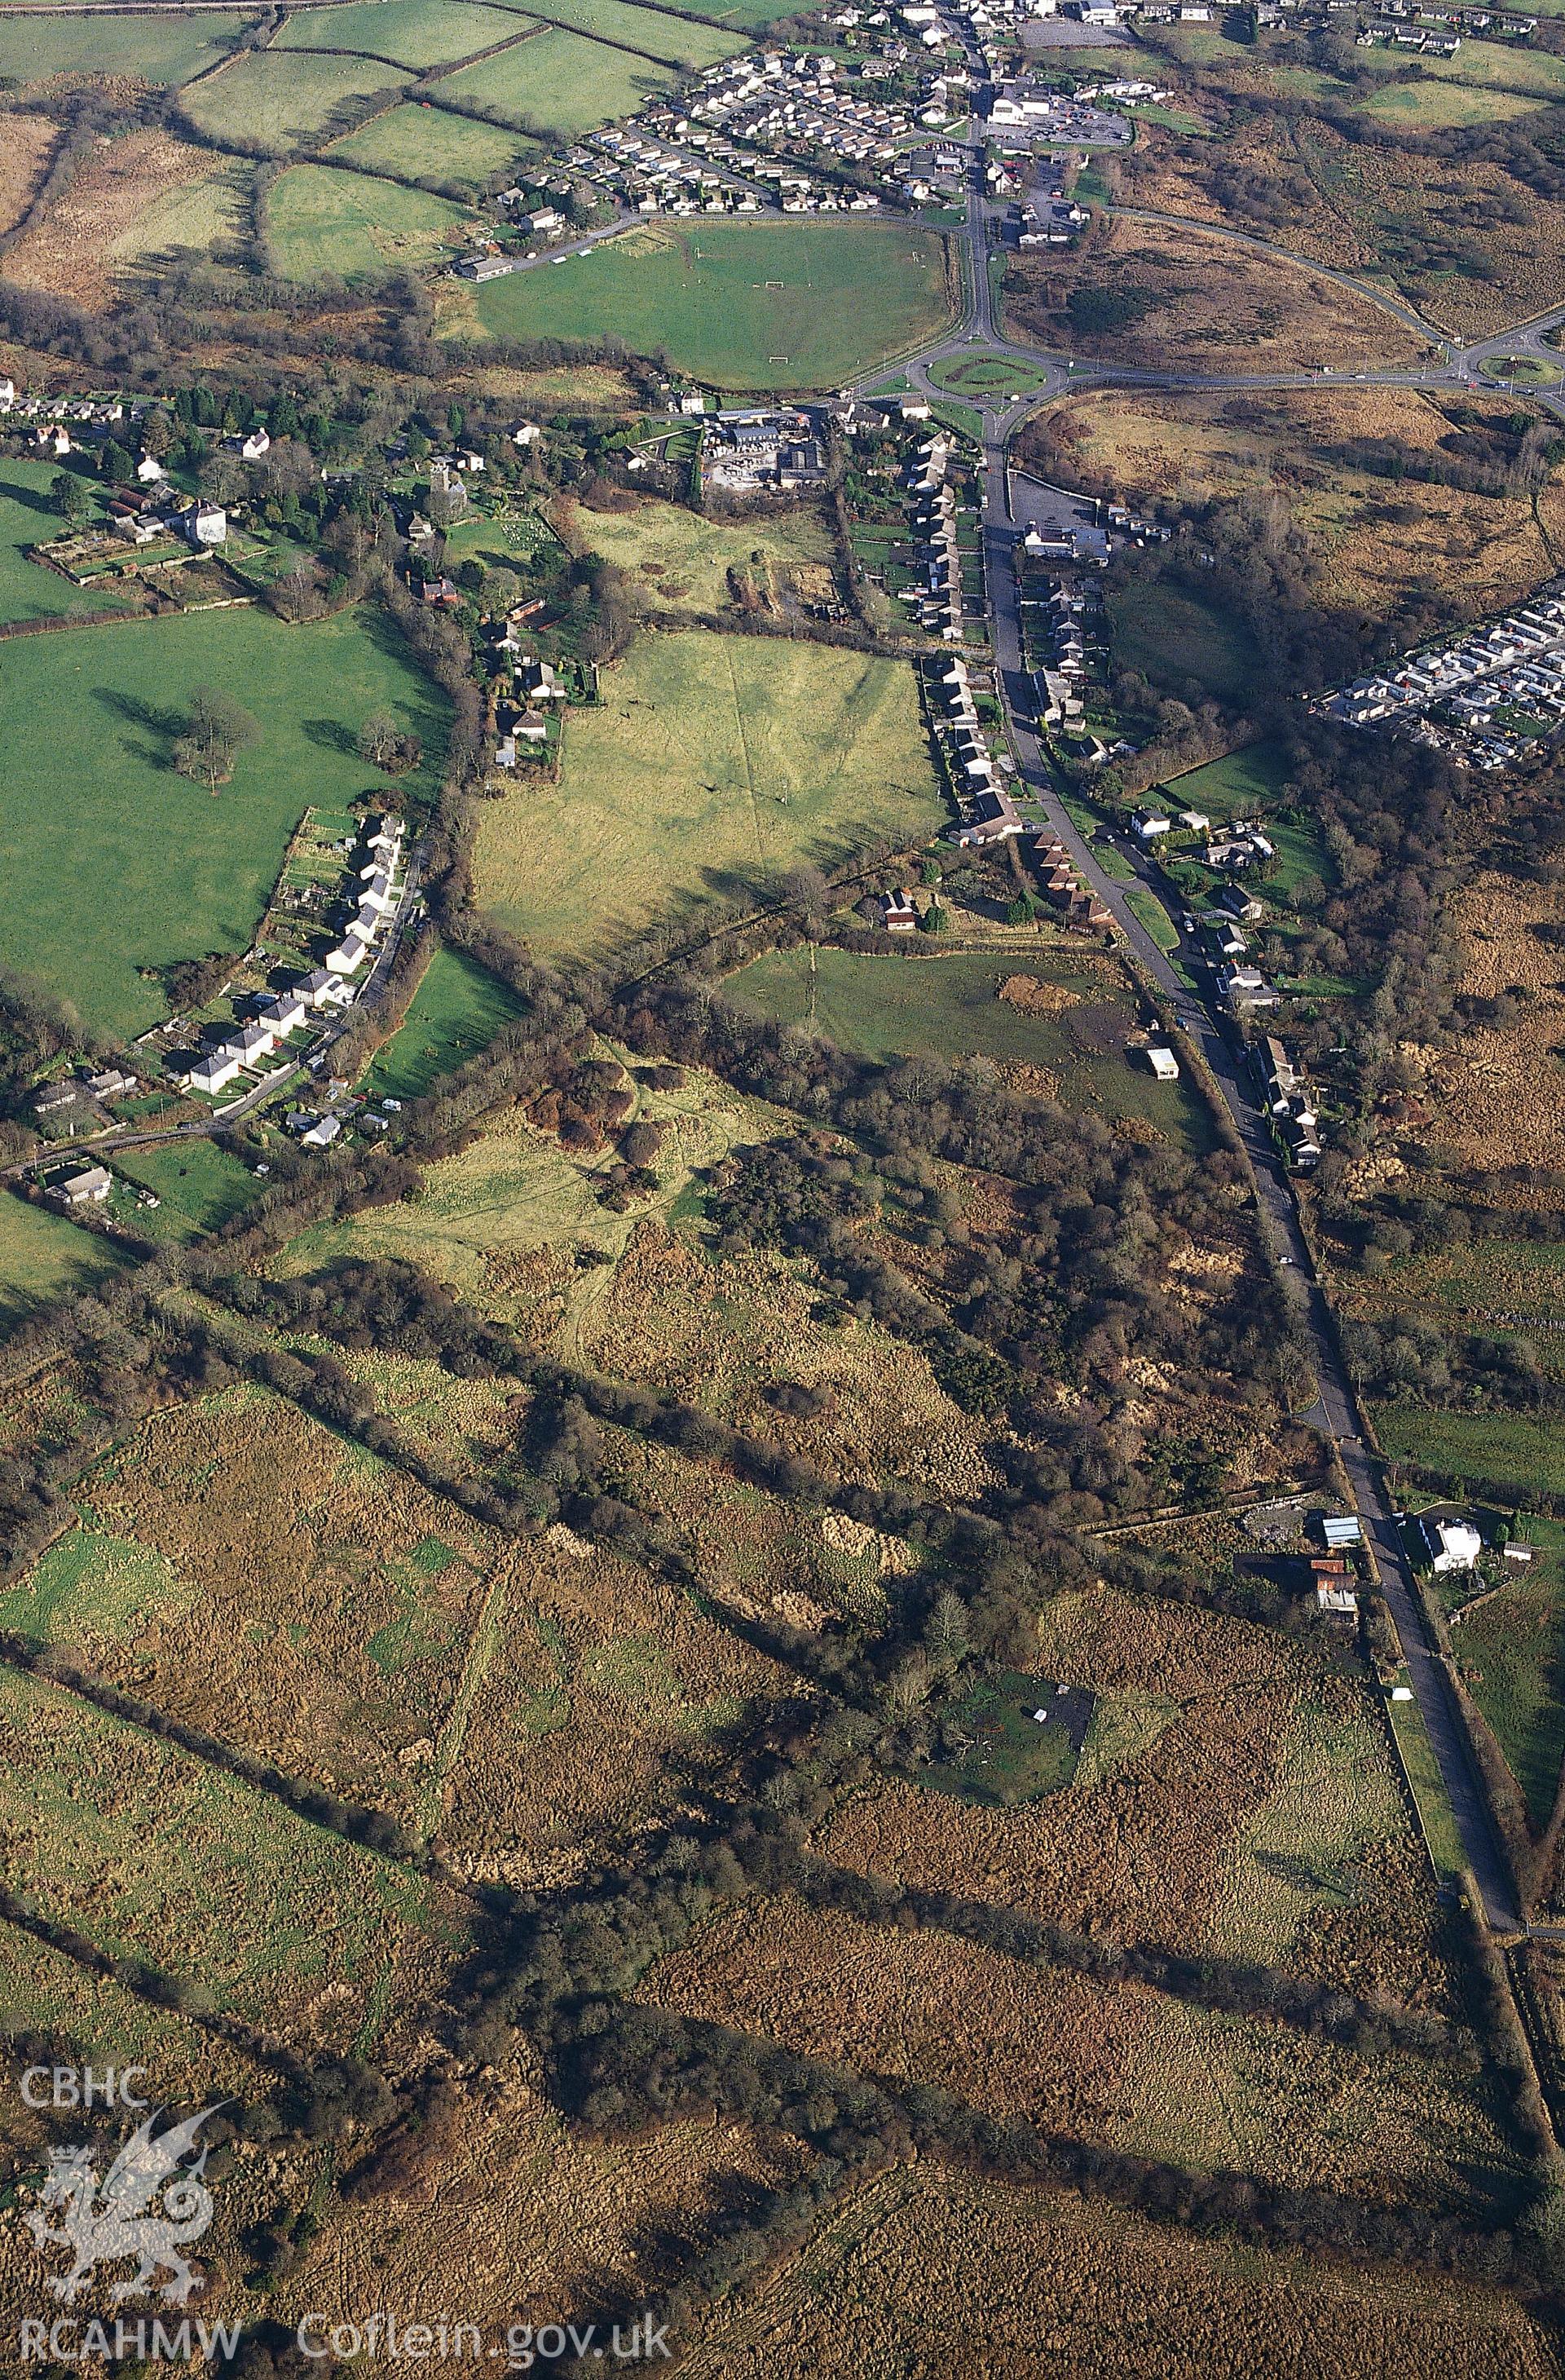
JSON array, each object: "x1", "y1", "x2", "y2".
[{"x1": 1451, "y1": 1521, "x2": 1565, "y2": 1830}]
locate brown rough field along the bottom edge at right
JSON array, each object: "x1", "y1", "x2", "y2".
[{"x1": 682, "y1": 2166, "x2": 1553, "y2": 2380}]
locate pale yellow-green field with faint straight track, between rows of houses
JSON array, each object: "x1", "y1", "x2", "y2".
[{"x1": 476, "y1": 631, "x2": 944, "y2": 950}]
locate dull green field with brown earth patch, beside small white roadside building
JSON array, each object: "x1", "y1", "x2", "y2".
[{"x1": 723, "y1": 945, "x2": 1210, "y2": 1147}]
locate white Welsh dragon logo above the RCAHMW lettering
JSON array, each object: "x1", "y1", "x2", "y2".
[{"x1": 26, "y1": 2101, "x2": 221, "y2": 2307}]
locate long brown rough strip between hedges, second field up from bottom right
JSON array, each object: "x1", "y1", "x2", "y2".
[{"x1": 635, "y1": 1895, "x2": 1515, "y2": 2204}]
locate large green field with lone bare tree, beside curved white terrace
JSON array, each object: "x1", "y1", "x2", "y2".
[{"x1": 0, "y1": 609, "x2": 445, "y2": 1033}]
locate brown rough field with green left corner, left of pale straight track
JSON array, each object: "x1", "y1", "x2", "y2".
[{"x1": 21, "y1": 1390, "x2": 505, "y2": 1823}]
